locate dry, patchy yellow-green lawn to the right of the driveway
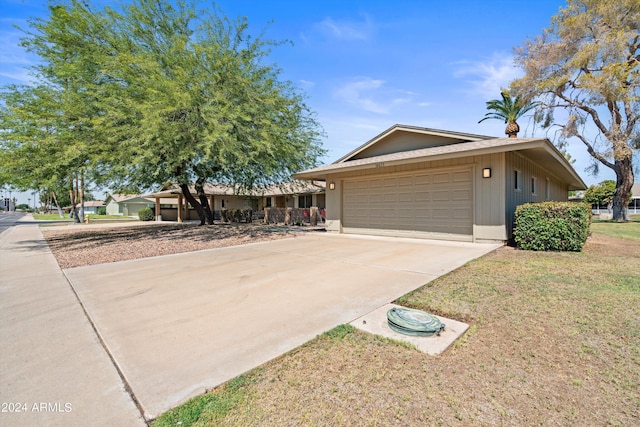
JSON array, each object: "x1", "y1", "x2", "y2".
[{"x1": 153, "y1": 223, "x2": 640, "y2": 427}]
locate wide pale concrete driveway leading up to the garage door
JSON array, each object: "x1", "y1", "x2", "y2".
[{"x1": 64, "y1": 233, "x2": 498, "y2": 419}]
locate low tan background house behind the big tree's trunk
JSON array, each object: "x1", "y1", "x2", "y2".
[{"x1": 144, "y1": 181, "x2": 324, "y2": 221}]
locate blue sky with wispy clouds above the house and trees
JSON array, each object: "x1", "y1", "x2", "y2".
[{"x1": 0, "y1": 0, "x2": 613, "y2": 203}]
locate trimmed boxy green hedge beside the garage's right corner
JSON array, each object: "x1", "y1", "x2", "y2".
[{"x1": 513, "y1": 202, "x2": 591, "y2": 252}]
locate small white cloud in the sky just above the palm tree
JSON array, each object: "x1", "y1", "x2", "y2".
[{"x1": 454, "y1": 54, "x2": 522, "y2": 99}]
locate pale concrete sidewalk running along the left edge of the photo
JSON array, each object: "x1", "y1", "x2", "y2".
[{"x1": 0, "y1": 225, "x2": 145, "y2": 426}]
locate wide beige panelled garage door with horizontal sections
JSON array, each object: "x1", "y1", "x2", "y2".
[{"x1": 343, "y1": 168, "x2": 473, "y2": 240}]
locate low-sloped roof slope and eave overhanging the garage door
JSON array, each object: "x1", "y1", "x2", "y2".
[{"x1": 294, "y1": 138, "x2": 586, "y2": 190}]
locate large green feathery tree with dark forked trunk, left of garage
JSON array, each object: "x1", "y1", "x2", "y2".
[{"x1": 89, "y1": 0, "x2": 323, "y2": 224}]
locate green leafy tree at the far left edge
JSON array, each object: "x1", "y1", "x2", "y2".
[{"x1": 0, "y1": 5, "x2": 104, "y2": 220}]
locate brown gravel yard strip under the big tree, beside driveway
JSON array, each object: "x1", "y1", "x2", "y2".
[{"x1": 42, "y1": 224, "x2": 314, "y2": 268}]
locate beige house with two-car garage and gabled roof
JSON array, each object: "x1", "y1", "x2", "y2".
[{"x1": 294, "y1": 125, "x2": 586, "y2": 242}]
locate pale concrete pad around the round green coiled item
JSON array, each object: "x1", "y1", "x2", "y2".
[{"x1": 351, "y1": 304, "x2": 469, "y2": 356}]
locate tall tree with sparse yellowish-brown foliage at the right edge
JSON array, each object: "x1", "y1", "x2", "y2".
[{"x1": 512, "y1": 0, "x2": 640, "y2": 220}]
